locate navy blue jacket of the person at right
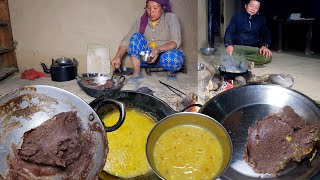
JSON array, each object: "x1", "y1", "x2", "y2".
[{"x1": 224, "y1": 9, "x2": 271, "y2": 47}]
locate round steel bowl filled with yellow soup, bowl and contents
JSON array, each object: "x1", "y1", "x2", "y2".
[{"x1": 146, "y1": 112, "x2": 233, "y2": 179}]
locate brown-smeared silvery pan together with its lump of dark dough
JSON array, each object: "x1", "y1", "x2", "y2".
[{"x1": 0, "y1": 85, "x2": 124, "y2": 179}]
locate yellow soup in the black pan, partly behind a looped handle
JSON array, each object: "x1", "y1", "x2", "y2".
[{"x1": 102, "y1": 108, "x2": 155, "y2": 178}]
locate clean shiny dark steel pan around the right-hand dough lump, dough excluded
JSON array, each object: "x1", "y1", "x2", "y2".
[{"x1": 199, "y1": 85, "x2": 320, "y2": 180}]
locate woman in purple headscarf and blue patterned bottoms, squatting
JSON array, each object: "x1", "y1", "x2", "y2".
[{"x1": 112, "y1": 0, "x2": 185, "y2": 83}]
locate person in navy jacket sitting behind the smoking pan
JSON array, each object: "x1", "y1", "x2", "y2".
[{"x1": 224, "y1": 0, "x2": 272, "y2": 64}]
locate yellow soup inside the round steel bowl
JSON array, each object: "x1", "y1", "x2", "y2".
[{"x1": 153, "y1": 125, "x2": 223, "y2": 179}]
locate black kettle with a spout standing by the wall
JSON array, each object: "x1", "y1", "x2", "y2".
[{"x1": 41, "y1": 57, "x2": 78, "y2": 82}]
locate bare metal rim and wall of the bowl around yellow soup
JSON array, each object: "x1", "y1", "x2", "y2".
[{"x1": 146, "y1": 112, "x2": 232, "y2": 179}]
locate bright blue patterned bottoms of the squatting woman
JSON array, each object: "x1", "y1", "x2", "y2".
[{"x1": 128, "y1": 33, "x2": 186, "y2": 73}]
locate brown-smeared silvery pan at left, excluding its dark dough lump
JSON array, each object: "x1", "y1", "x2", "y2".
[{"x1": 0, "y1": 85, "x2": 116, "y2": 179}]
